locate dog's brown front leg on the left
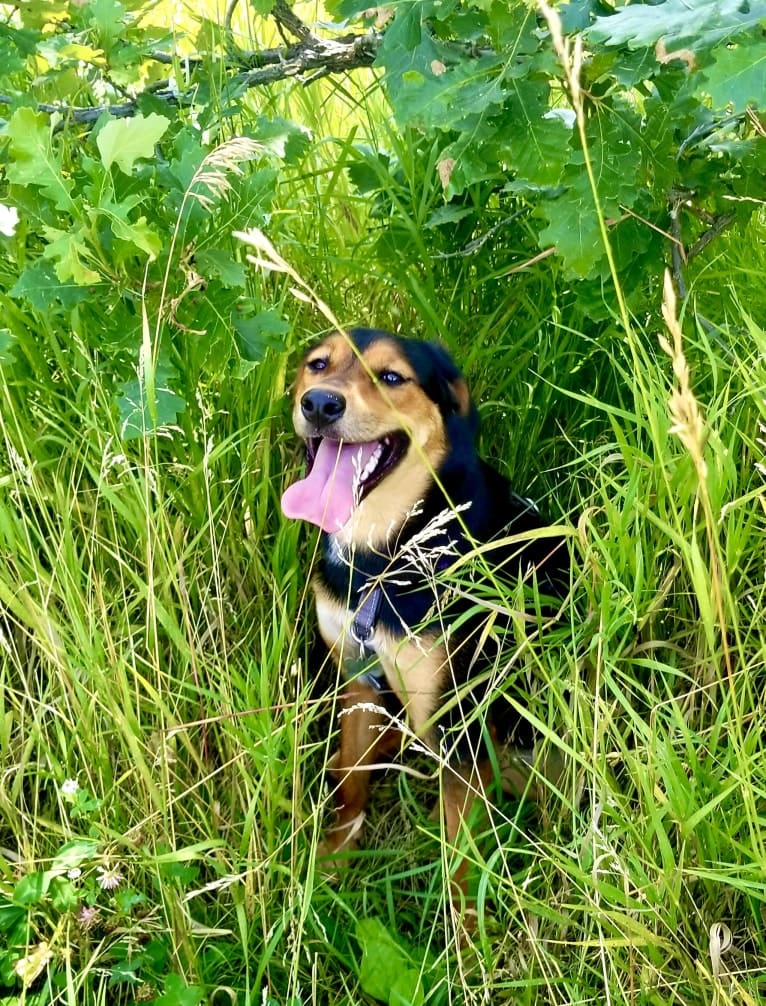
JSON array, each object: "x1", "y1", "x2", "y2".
[{"x1": 322, "y1": 681, "x2": 399, "y2": 855}]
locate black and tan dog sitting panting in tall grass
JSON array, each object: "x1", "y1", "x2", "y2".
[{"x1": 282, "y1": 328, "x2": 569, "y2": 882}]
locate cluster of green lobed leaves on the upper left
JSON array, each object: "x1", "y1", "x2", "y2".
[{"x1": 0, "y1": 3, "x2": 310, "y2": 440}]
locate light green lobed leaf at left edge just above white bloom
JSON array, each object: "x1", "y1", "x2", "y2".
[{"x1": 5, "y1": 109, "x2": 71, "y2": 209}]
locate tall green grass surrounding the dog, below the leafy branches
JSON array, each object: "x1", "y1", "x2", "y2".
[{"x1": 0, "y1": 7, "x2": 766, "y2": 1006}]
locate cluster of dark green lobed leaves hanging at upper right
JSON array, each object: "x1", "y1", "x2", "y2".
[{"x1": 334, "y1": 0, "x2": 766, "y2": 287}]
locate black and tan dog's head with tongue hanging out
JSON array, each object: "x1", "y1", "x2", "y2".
[{"x1": 282, "y1": 328, "x2": 476, "y2": 544}]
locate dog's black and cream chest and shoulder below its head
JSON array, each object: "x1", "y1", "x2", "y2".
[{"x1": 313, "y1": 462, "x2": 561, "y2": 742}]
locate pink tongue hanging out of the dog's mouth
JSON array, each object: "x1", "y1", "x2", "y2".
[{"x1": 282, "y1": 437, "x2": 378, "y2": 534}]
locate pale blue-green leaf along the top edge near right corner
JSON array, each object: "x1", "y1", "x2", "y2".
[{"x1": 587, "y1": 0, "x2": 766, "y2": 50}]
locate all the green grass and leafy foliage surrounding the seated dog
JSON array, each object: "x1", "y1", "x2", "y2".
[{"x1": 0, "y1": 0, "x2": 766, "y2": 1006}]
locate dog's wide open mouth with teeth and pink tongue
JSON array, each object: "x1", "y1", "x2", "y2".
[{"x1": 282, "y1": 433, "x2": 409, "y2": 534}]
